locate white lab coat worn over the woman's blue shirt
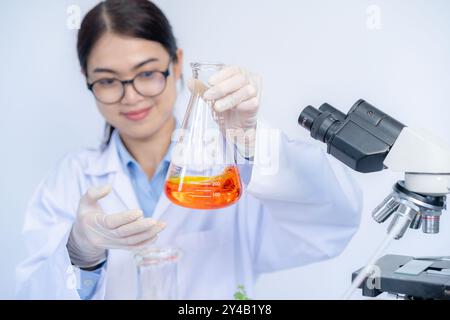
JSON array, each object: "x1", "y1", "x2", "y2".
[{"x1": 16, "y1": 121, "x2": 361, "y2": 299}]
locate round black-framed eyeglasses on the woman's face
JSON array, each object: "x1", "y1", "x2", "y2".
[{"x1": 87, "y1": 65, "x2": 170, "y2": 104}]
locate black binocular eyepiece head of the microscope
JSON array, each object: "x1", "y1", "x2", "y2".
[{"x1": 298, "y1": 100, "x2": 405, "y2": 173}]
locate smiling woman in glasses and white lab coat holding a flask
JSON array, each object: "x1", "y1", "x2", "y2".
[{"x1": 17, "y1": 0, "x2": 361, "y2": 299}]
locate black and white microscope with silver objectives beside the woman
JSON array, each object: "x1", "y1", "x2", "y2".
[{"x1": 298, "y1": 100, "x2": 450, "y2": 299}]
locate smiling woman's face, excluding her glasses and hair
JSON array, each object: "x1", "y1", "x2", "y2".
[{"x1": 87, "y1": 33, "x2": 183, "y2": 140}]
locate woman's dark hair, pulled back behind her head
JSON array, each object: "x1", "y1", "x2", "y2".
[{"x1": 77, "y1": 0, "x2": 177, "y2": 147}]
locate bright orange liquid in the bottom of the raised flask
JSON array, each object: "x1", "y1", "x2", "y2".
[{"x1": 165, "y1": 166, "x2": 242, "y2": 210}]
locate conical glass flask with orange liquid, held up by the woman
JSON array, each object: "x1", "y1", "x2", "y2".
[{"x1": 165, "y1": 63, "x2": 242, "y2": 210}]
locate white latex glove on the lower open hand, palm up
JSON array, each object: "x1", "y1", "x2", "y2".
[{"x1": 67, "y1": 185, "x2": 165, "y2": 268}]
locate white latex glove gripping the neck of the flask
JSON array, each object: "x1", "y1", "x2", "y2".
[{"x1": 188, "y1": 66, "x2": 261, "y2": 158}]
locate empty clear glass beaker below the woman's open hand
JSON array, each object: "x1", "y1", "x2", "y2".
[{"x1": 135, "y1": 247, "x2": 181, "y2": 300}]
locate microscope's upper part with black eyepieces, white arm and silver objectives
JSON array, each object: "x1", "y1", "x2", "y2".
[{"x1": 298, "y1": 100, "x2": 450, "y2": 239}]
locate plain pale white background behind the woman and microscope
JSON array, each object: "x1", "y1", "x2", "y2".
[{"x1": 0, "y1": 0, "x2": 450, "y2": 299}]
